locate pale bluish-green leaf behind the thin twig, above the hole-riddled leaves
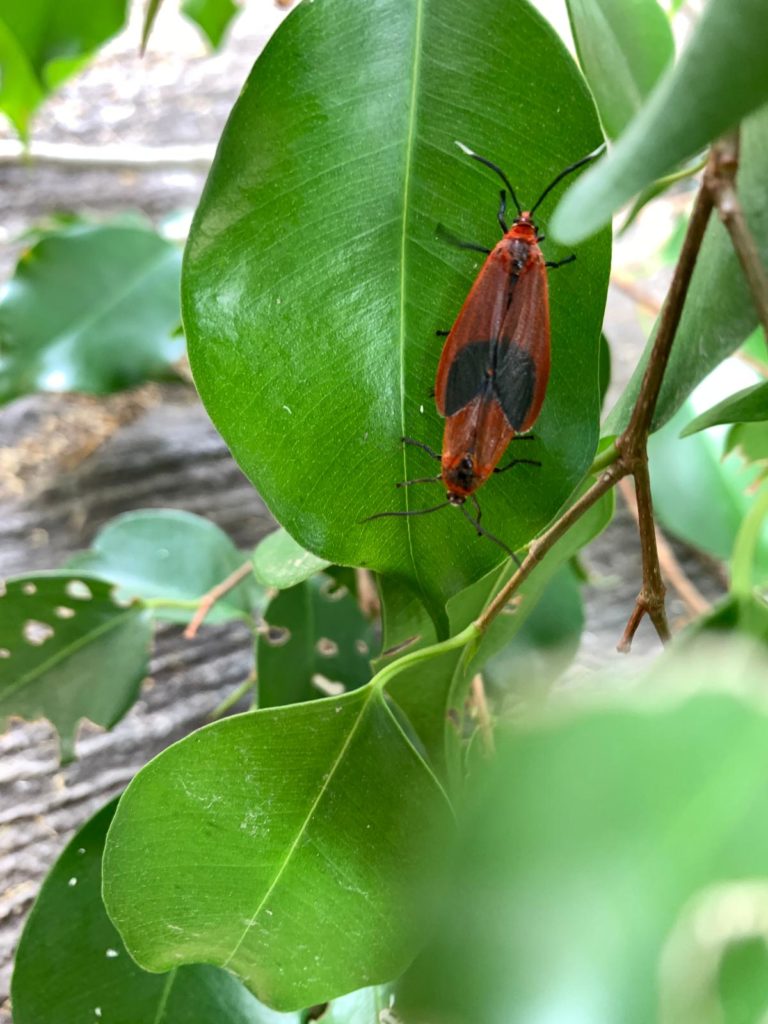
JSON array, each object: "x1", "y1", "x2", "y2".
[{"x1": 68, "y1": 509, "x2": 264, "y2": 625}]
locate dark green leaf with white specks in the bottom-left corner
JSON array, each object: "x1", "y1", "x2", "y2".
[{"x1": 11, "y1": 801, "x2": 301, "y2": 1024}]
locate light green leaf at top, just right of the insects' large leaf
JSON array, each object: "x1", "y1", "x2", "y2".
[{"x1": 567, "y1": 0, "x2": 675, "y2": 138}]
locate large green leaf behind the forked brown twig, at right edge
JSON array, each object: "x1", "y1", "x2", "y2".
[{"x1": 603, "y1": 106, "x2": 768, "y2": 434}]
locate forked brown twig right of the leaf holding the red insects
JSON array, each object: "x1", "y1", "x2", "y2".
[{"x1": 475, "y1": 139, "x2": 733, "y2": 651}]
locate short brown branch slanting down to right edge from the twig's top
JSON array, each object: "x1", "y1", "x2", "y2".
[{"x1": 705, "y1": 131, "x2": 768, "y2": 350}]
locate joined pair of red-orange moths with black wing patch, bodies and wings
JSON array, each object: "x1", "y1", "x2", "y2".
[{"x1": 435, "y1": 212, "x2": 550, "y2": 504}]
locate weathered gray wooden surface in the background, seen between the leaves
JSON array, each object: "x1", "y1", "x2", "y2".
[{"x1": 0, "y1": 0, "x2": 719, "y2": 1024}]
